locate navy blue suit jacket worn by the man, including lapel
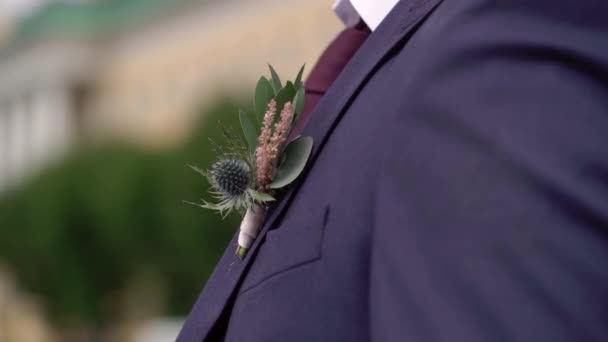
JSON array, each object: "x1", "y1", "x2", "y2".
[{"x1": 178, "y1": 0, "x2": 608, "y2": 342}]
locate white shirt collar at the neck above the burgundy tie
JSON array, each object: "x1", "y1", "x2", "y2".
[{"x1": 334, "y1": 0, "x2": 399, "y2": 31}]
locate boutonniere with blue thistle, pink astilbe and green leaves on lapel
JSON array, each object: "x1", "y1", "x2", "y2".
[{"x1": 188, "y1": 66, "x2": 313, "y2": 259}]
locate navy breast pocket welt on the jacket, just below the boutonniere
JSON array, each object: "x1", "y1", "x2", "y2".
[{"x1": 240, "y1": 207, "x2": 329, "y2": 294}]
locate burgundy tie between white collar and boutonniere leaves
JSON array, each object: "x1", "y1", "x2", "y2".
[{"x1": 292, "y1": 21, "x2": 371, "y2": 136}]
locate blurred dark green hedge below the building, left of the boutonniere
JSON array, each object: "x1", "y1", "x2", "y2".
[{"x1": 0, "y1": 101, "x2": 243, "y2": 322}]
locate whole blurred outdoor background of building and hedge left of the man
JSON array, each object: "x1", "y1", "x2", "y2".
[{"x1": 0, "y1": 0, "x2": 341, "y2": 342}]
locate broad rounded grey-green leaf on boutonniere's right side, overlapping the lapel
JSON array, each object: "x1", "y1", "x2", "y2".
[{"x1": 268, "y1": 137, "x2": 313, "y2": 189}]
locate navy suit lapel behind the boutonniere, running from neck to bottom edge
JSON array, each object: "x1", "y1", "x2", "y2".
[{"x1": 178, "y1": 0, "x2": 442, "y2": 342}]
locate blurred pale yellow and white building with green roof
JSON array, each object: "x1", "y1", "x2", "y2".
[{"x1": 0, "y1": 0, "x2": 341, "y2": 192}]
